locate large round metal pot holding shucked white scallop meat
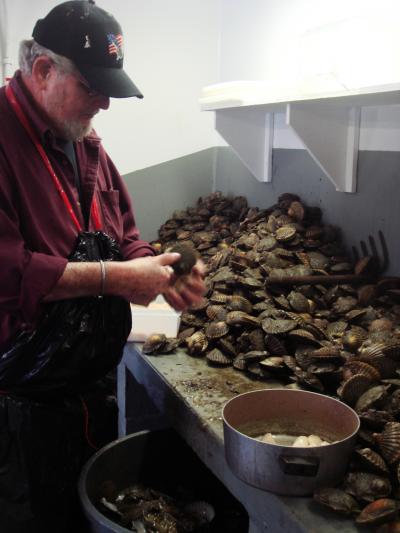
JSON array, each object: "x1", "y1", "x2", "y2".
[{"x1": 223, "y1": 389, "x2": 360, "y2": 496}]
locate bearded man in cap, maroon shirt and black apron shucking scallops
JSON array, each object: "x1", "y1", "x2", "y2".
[{"x1": 0, "y1": 1, "x2": 204, "y2": 533}]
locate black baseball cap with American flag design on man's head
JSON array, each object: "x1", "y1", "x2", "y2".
[{"x1": 32, "y1": 0, "x2": 143, "y2": 98}]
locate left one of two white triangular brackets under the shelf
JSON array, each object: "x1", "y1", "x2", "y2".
[{"x1": 215, "y1": 107, "x2": 274, "y2": 182}]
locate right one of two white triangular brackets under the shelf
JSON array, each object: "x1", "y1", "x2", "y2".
[{"x1": 286, "y1": 102, "x2": 360, "y2": 192}]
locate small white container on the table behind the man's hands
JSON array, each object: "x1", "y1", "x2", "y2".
[{"x1": 128, "y1": 295, "x2": 181, "y2": 342}]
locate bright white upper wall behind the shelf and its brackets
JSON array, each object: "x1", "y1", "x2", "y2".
[{"x1": 218, "y1": 0, "x2": 400, "y2": 151}]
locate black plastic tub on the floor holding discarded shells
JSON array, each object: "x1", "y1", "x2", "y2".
[{"x1": 78, "y1": 429, "x2": 248, "y2": 533}]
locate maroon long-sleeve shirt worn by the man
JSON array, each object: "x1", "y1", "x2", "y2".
[{"x1": 0, "y1": 72, "x2": 154, "y2": 352}]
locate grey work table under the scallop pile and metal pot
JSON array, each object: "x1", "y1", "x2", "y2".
[{"x1": 118, "y1": 343, "x2": 359, "y2": 533}]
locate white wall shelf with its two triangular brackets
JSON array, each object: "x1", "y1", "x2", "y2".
[{"x1": 200, "y1": 82, "x2": 400, "y2": 192}]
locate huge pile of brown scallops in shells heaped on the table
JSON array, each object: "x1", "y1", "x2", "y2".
[{"x1": 148, "y1": 192, "x2": 400, "y2": 531}]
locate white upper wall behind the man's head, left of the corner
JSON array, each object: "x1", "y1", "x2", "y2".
[{"x1": 0, "y1": 0, "x2": 220, "y2": 174}]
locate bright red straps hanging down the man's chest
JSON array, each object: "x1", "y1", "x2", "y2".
[{"x1": 6, "y1": 84, "x2": 101, "y2": 232}]
